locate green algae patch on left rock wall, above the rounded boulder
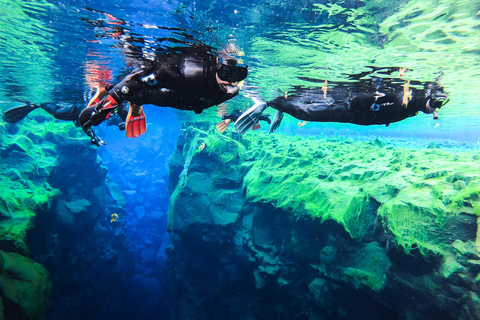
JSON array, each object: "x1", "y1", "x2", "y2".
[{"x1": 0, "y1": 118, "x2": 84, "y2": 253}]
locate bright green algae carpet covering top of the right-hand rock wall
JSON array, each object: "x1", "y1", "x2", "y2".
[{"x1": 174, "y1": 128, "x2": 480, "y2": 258}]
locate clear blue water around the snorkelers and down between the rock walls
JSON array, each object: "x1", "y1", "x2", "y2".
[{"x1": 0, "y1": 0, "x2": 480, "y2": 319}]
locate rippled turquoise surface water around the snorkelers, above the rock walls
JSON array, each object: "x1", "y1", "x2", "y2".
[{"x1": 0, "y1": 0, "x2": 480, "y2": 143}]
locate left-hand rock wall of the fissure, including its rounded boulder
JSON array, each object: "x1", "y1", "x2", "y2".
[{"x1": 0, "y1": 117, "x2": 133, "y2": 319}]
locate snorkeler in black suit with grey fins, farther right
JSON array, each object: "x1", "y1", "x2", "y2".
[{"x1": 235, "y1": 72, "x2": 448, "y2": 134}]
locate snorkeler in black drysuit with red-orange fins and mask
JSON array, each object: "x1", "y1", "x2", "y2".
[{"x1": 79, "y1": 45, "x2": 248, "y2": 141}]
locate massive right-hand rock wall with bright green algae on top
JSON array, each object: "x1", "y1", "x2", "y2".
[{"x1": 166, "y1": 126, "x2": 480, "y2": 320}]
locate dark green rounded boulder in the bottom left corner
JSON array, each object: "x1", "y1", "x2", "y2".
[{"x1": 0, "y1": 251, "x2": 51, "y2": 319}]
